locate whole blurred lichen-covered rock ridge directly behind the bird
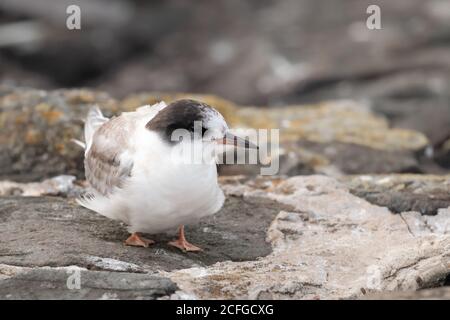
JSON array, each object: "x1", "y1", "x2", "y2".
[{"x1": 0, "y1": 87, "x2": 445, "y2": 181}]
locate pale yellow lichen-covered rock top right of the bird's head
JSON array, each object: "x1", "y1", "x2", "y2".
[{"x1": 235, "y1": 101, "x2": 429, "y2": 150}]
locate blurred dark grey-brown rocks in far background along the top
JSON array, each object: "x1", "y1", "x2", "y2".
[{"x1": 0, "y1": 0, "x2": 450, "y2": 109}]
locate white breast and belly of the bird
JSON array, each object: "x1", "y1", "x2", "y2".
[{"x1": 95, "y1": 129, "x2": 224, "y2": 233}]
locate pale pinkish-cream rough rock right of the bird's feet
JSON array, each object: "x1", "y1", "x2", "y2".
[{"x1": 164, "y1": 176, "x2": 450, "y2": 299}]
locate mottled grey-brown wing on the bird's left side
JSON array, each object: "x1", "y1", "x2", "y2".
[{"x1": 84, "y1": 116, "x2": 134, "y2": 196}]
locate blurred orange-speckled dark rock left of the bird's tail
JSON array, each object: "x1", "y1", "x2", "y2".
[{"x1": 0, "y1": 88, "x2": 117, "y2": 181}]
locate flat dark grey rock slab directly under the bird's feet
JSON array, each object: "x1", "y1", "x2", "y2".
[{"x1": 0, "y1": 197, "x2": 286, "y2": 272}]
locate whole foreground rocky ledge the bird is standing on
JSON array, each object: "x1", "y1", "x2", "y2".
[{"x1": 0, "y1": 175, "x2": 450, "y2": 299}]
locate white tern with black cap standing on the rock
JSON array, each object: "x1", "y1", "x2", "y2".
[{"x1": 76, "y1": 99, "x2": 258, "y2": 251}]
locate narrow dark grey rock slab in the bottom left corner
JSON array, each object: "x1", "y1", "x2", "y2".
[{"x1": 0, "y1": 265, "x2": 177, "y2": 300}]
